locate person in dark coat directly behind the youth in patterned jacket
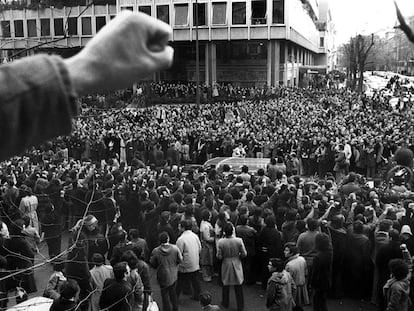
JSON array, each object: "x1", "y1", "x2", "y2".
[{"x1": 257, "y1": 216, "x2": 284, "y2": 287}]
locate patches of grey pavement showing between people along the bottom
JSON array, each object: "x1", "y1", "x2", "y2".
[{"x1": 9, "y1": 238, "x2": 375, "y2": 311}]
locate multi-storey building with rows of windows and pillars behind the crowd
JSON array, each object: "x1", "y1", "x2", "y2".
[{"x1": 0, "y1": 0, "x2": 332, "y2": 86}]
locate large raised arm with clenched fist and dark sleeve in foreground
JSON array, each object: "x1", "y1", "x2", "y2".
[{"x1": 0, "y1": 11, "x2": 173, "y2": 161}]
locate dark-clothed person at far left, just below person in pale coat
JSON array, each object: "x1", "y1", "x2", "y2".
[{"x1": 5, "y1": 219, "x2": 37, "y2": 294}]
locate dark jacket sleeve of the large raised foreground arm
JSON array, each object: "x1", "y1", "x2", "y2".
[{"x1": 0, "y1": 55, "x2": 78, "y2": 161}]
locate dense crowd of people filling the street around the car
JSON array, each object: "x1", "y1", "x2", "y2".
[{"x1": 0, "y1": 87, "x2": 414, "y2": 310}]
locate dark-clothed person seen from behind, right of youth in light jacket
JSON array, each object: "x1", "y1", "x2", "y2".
[{"x1": 309, "y1": 233, "x2": 333, "y2": 311}]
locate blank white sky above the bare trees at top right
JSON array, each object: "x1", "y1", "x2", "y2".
[{"x1": 328, "y1": 0, "x2": 414, "y2": 45}]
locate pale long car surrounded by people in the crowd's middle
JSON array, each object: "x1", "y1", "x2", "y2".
[{"x1": 203, "y1": 157, "x2": 270, "y2": 174}]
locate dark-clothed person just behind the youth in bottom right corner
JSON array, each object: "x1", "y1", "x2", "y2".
[{"x1": 374, "y1": 229, "x2": 403, "y2": 311}]
